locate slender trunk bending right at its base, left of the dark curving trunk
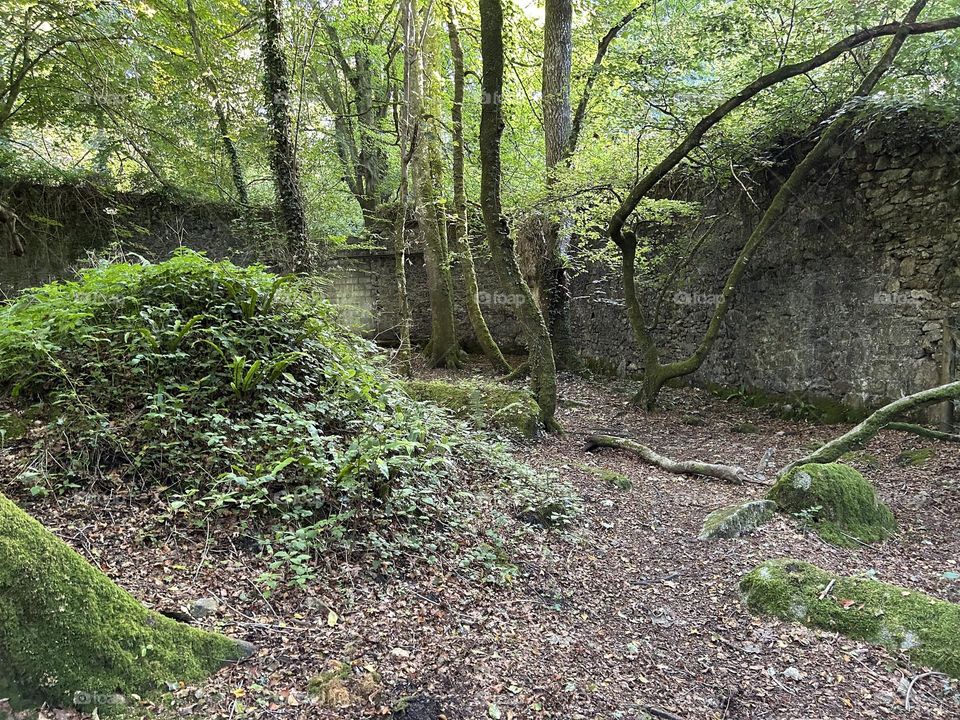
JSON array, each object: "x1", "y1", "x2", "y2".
[{"x1": 446, "y1": 0, "x2": 511, "y2": 373}]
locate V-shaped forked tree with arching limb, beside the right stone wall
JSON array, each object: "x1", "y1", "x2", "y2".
[{"x1": 608, "y1": 0, "x2": 960, "y2": 409}]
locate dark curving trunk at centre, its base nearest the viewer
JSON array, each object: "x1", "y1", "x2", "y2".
[{"x1": 480, "y1": 0, "x2": 558, "y2": 430}]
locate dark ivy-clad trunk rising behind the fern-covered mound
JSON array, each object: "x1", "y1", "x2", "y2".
[{"x1": 261, "y1": 0, "x2": 315, "y2": 272}]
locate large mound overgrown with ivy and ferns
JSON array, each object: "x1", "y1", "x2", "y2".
[{"x1": 0, "y1": 252, "x2": 570, "y2": 582}]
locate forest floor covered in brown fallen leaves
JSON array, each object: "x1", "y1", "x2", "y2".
[{"x1": 0, "y1": 366, "x2": 960, "y2": 720}]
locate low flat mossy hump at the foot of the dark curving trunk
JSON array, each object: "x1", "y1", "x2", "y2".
[{"x1": 404, "y1": 380, "x2": 542, "y2": 438}]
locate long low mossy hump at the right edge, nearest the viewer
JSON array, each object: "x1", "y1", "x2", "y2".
[{"x1": 740, "y1": 560, "x2": 960, "y2": 677}]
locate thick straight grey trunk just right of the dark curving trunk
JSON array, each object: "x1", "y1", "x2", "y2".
[{"x1": 537, "y1": 0, "x2": 579, "y2": 370}]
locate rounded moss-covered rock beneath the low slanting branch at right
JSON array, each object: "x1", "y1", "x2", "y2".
[{"x1": 767, "y1": 463, "x2": 897, "y2": 546}]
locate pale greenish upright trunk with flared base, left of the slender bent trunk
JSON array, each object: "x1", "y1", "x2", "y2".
[{"x1": 408, "y1": 3, "x2": 461, "y2": 367}]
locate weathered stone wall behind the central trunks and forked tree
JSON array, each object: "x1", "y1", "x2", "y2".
[{"x1": 343, "y1": 114, "x2": 960, "y2": 416}]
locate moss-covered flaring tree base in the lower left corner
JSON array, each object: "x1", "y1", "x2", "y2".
[{"x1": 0, "y1": 495, "x2": 245, "y2": 708}]
